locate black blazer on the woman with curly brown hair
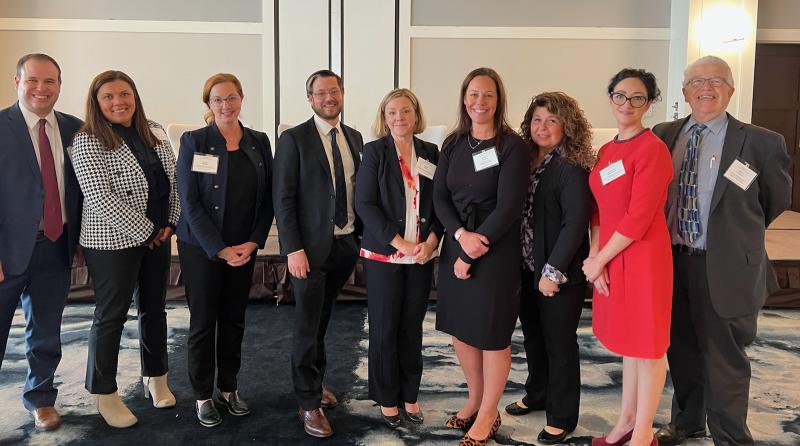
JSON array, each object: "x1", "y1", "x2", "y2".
[{"x1": 533, "y1": 154, "x2": 592, "y2": 287}]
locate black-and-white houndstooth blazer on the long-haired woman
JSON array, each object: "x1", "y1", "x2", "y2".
[{"x1": 68, "y1": 121, "x2": 180, "y2": 250}]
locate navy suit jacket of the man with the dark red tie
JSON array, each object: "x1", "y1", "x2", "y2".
[{"x1": 0, "y1": 102, "x2": 83, "y2": 275}]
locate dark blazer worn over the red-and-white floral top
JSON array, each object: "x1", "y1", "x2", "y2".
[{"x1": 355, "y1": 135, "x2": 444, "y2": 255}]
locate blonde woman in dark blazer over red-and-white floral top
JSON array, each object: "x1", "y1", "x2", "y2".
[{"x1": 355, "y1": 88, "x2": 443, "y2": 428}]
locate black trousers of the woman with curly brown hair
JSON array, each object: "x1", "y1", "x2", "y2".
[{"x1": 519, "y1": 268, "x2": 586, "y2": 431}]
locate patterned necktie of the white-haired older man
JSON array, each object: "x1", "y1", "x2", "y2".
[{"x1": 678, "y1": 124, "x2": 706, "y2": 244}]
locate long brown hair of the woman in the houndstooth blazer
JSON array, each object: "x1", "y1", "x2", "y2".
[{"x1": 81, "y1": 70, "x2": 158, "y2": 150}]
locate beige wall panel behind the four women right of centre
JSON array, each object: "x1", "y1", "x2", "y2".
[{"x1": 411, "y1": 39, "x2": 669, "y2": 131}]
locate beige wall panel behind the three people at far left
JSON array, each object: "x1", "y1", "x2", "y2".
[{"x1": 0, "y1": 31, "x2": 262, "y2": 127}]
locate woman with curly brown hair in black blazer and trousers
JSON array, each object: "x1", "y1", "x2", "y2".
[{"x1": 506, "y1": 92, "x2": 595, "y2": 444}]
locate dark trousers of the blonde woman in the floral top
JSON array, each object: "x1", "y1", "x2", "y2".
[{"x1": 364, "y1": 260, "x2": 433, "y2": 407}]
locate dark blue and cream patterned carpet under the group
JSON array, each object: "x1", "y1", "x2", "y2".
[{"x1": 0, "y1": 302, "x2": 800, "y2": 446}]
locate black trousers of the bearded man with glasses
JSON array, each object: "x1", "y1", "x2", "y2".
[{"x1": 291, "y1": 235, "x2": 358, "y2": 410}]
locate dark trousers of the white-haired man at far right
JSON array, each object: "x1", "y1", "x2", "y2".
[{"x1": 667, "y1": 252, "x2": 758, "y2": 445}]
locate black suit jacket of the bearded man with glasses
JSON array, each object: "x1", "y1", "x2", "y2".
[{"x1": 272, "y1": 117, "x2": 364, "y2": 268}]
